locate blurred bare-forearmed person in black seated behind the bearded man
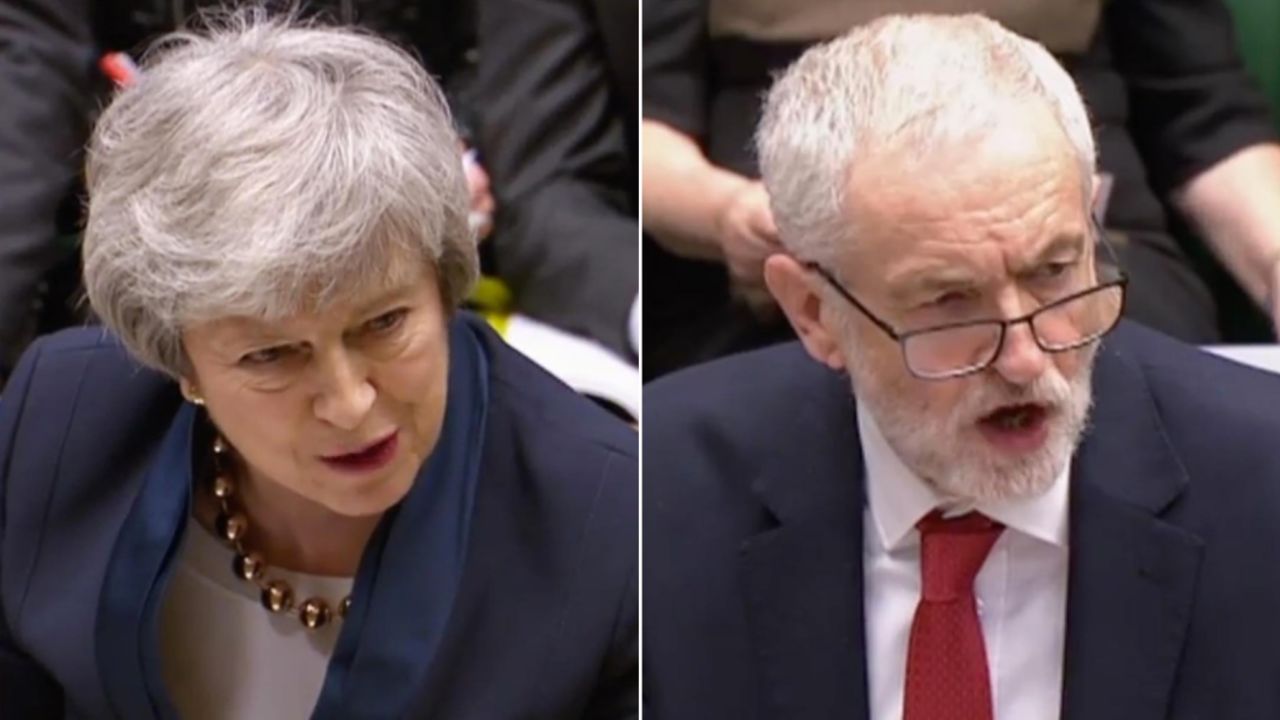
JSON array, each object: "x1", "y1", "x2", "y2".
[{"x1": 641, "y1": 0, "x2": 1280, "y2": 377}]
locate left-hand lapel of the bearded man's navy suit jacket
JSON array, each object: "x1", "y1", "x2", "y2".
[{"x1": 740, "y1": 375, "x2": 867, "y2": 719}]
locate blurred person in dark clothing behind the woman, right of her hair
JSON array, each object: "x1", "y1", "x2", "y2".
[{"x1": 474, "y1": 0, "x2": 640, "y2": 361}]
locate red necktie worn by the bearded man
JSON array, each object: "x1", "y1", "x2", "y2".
[{"x1": 902, "y1": 511, "x2": 1005, "y2": 720}]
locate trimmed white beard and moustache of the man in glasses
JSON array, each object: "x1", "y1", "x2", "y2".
[{"x1": 846, "y1": 346, "x2": 1096, "y2": 501}]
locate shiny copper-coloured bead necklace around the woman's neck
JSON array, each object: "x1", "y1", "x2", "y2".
[{"x1": 212, "y1": 436, "x2": 351, "y2": 630}]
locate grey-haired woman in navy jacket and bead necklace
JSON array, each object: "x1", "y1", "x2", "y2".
[{"x1": 0, "y1": 12, "x2": 637, "y2": 719}]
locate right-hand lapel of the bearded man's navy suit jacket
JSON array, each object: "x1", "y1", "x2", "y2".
[{"x1": 1062, "y1": 333, "x2": 1203, "y2": 720}]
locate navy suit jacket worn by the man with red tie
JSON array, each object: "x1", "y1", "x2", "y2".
[{"x1": 644, "y1": 324, "x2": 1280, "y2": 720}]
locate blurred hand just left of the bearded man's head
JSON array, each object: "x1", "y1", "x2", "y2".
[{"x1": 716, "y1": 181, "x2": 782, "y2": 310}]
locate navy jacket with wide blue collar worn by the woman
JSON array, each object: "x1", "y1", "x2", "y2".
[{"x1": 0, "y1": 315, "x2": 639, "y2": 720}]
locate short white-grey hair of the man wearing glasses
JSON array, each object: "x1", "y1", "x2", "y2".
[{"x1": 756, "y1": 14, "x2": 1096, "y2": 260}]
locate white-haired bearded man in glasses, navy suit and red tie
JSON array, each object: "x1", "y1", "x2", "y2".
[{"x1": 644, "y1": 15, "x2": 1280, "y2": 720}]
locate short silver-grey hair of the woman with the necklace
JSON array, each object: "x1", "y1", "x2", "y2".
[{"x1": 83, "y1": 8, "x2": 479, "y2": 377}]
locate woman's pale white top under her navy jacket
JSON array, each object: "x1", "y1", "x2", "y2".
[{"x1": 160, "y1": 519, "x2": 352, "y2": 720}]
